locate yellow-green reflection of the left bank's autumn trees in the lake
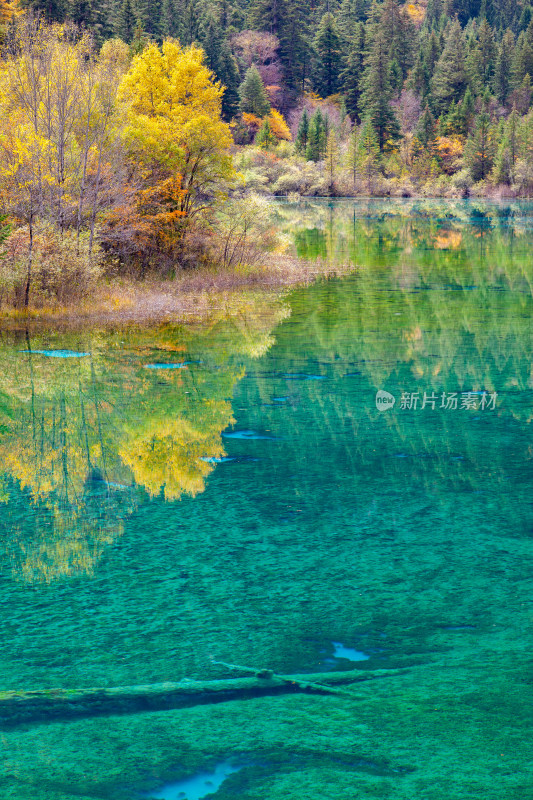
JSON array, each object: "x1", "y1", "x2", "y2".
[{"x1": 0, "y1": 296, "x2": 287, "y2": 581}]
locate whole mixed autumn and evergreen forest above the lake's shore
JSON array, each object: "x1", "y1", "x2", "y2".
[{"x1": 0, "y1": 0, "x2": 533, "y2": 308}]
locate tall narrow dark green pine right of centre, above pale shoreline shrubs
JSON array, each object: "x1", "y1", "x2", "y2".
[{"x1": 361, "y1": 32, "x2": 400, "y2": 152}]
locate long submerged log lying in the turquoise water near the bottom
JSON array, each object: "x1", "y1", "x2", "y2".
[{"x1": 0, "y1": 670, "x2": 403, "y2": 727}]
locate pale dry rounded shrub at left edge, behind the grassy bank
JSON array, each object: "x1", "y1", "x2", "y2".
[{"x1": 0, "y1": 224, "x2": 102, "y2": 308}]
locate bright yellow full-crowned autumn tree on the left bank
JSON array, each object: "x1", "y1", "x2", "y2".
[{"x1": 118, "y1": 39, "x2": 234, "y2": 221}]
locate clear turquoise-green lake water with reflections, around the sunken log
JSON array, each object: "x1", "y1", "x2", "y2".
[{"x1": 0, "y1": 201, "x2": 533, "y2": 800}]
